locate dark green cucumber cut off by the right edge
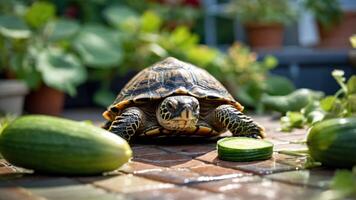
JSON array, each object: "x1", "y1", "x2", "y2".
[{"x1": 307, "y1": 117, "x2": 356, "y2": 168}]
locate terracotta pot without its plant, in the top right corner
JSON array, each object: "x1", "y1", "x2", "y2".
[{"x1": 318, "y1": 11, "x2": 356, "y2": 48}]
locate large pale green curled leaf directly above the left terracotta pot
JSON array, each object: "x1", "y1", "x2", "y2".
[{"x1": 37, "y1": 48, "x2": 87, "y2": 95}]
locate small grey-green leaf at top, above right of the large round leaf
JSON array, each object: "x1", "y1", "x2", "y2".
[{"x1": 104, "y1": 6, "x2": 139, "y2": 30}]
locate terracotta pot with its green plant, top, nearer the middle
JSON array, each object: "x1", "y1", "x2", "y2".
[{"x1": 227, "y1": 0, "x2": 296, "y2": 48}]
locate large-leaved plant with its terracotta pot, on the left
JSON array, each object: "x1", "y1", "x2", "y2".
[{"x1": 0, "y1": 2, "x2": 86, "y2": 115}]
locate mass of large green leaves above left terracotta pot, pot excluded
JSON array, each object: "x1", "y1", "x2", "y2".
[{"x1": 0, "y1": 1, "x2": 122, "y2": 95}]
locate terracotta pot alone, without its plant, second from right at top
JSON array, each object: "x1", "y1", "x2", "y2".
[{"x1": 245, "y1": 24, "x2": 284, "y2": 49}]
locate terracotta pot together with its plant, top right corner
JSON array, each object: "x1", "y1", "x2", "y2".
[{"x1": 305, "y1": 0, "x2": 356, "y2": 48}]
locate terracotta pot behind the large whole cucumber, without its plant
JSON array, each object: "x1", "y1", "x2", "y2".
[{"x1": 25, "y1": 85, "x2": 65, "y2": 116}]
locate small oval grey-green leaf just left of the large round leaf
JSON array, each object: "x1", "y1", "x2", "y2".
[{"x1": 45, "y1": 19, "x2": 80, "y2": 41}]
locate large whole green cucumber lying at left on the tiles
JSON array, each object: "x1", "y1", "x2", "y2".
[{"x1": 0, "y1": 115, "x2": 132, "y2": 175}]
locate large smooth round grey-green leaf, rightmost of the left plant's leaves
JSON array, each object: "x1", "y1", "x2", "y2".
[{"x1": 74, "y1": 25, "x2": 123, "y2": 68}]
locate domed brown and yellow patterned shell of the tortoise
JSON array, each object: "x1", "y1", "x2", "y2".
[{"x1": 103, "y1": 57, "x2": 243, "y2": 121}]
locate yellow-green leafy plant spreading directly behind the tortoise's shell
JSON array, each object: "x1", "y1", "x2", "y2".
[{"x1": 97, "y1": 6, "x2": 286, "y2": 112}]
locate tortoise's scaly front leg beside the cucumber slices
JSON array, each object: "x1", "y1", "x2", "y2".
[{"x1": 214, "y1": 105, "x2": 265, "y2": 138}]
